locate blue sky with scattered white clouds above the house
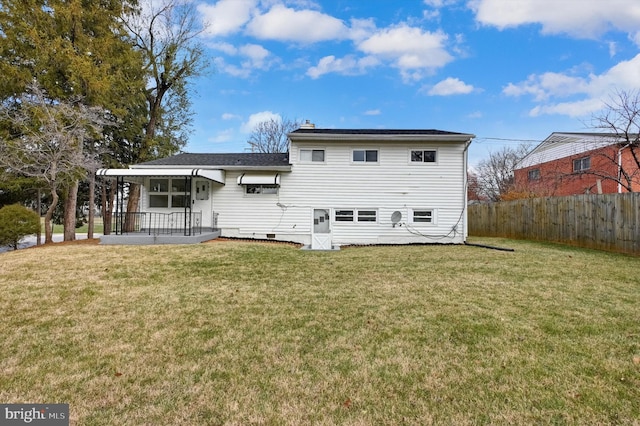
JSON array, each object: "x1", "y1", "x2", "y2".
[{"x1": 180, "y1": 0, "x2": 640, "y2": 165}]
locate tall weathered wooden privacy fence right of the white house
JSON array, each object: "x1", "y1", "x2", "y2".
[{"x1": 469, "y1": 193, "x2": 640, "y2": 254}]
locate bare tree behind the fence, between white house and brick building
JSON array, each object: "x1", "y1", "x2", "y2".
[{"x1": 476, "y1": 144, "x2": 530, "y2": 201}]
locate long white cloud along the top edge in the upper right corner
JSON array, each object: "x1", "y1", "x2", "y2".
[{"x1": 469, "y1": 0, "x2": 640, "y2": 38}]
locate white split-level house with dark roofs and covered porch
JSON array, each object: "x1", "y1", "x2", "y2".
[{"x1": 98, "y1": 125, "x2": 474, "y2": 249}]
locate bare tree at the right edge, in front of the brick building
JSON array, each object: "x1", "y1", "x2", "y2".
[{"x1": 582, "y1": 91, "x2": 640, "y2": 192}]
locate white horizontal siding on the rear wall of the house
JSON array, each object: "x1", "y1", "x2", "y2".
[{"x1": 211, "y1": 140, "x2": 466, "y2": 245}]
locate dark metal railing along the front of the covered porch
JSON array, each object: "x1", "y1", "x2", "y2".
[{"x1": 111, "y1": 212, "x2": 202, "y2": 235}]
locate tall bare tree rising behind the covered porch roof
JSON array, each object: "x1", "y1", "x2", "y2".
[{"x1": 124, "y1": 0, "x2": 206, "y2": 220}]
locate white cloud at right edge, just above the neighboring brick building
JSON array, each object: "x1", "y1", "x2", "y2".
[{"x1": 503, "y1": 54, "x2": 640, "y2": 117}]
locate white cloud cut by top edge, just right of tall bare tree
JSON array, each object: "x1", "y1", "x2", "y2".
[{"x1": 197, "y1": 0, "x2": 257, "y2": 37}]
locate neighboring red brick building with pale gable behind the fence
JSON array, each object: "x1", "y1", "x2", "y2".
[{"x1": 514, "y1": 132, "x2": 640, "y2": 196}]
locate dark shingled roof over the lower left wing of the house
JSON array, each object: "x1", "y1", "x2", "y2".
[{"x1": 138, "y1": 152, "x2": 289, "y2": 167}]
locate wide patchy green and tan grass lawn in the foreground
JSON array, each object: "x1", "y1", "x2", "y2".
[{"x1": 0, "y1": 239, "x2": 640, "y2": 425}]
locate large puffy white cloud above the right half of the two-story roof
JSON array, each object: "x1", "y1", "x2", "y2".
[{"x1": 358, "y1": 24, "x2": 453, "y2": 80}]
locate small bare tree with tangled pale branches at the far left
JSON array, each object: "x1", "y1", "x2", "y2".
[{"x1": 0, "y1": 84, "x2": 103, "y2": 243}]
